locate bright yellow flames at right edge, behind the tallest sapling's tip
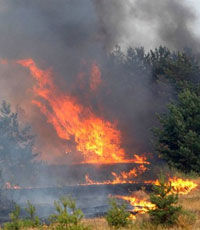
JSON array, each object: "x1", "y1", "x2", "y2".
[{"x1": 154, "y1": 177, "x2": 197, "y2": 195}]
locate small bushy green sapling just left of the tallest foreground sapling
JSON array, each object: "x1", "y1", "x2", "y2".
[{"x1": 106, "y1": 198, "x2": 131, "y2": 229}]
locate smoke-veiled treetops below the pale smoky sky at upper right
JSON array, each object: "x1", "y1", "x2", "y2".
[{"x1": 111, "y1": 46, "x2": 200, "y2": 89}]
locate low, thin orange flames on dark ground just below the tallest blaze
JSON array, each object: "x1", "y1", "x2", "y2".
[{"x1": 84, "y1": 165, "x2": 147, "y2": 185}]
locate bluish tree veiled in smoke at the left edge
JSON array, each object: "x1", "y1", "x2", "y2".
[{"x1": 0, "y1": 101, "x2": 36, "y2": 184}]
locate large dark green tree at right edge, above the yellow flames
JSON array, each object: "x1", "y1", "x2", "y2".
[{"x1": 154, "y1": 89, "x2": 200, "y2": 173}]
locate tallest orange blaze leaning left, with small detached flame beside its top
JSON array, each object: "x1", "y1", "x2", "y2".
[{"x1": 17, "y1": 59, "x2": 148, "y2": 164}]
